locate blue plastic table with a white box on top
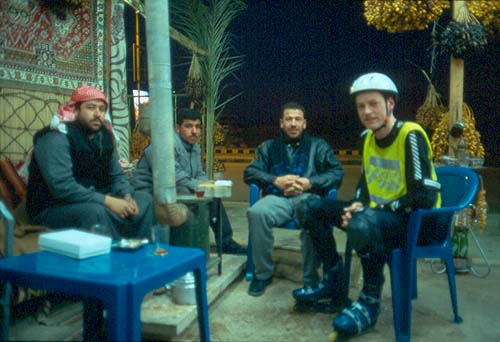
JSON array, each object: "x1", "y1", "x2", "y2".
[{"x1": 0, "y1": 244, "x2": 210, "y2": 341}]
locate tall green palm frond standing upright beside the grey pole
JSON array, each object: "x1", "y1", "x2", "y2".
[{"x1": 171, "y1": 0, "x2": 246, "y2": 178}]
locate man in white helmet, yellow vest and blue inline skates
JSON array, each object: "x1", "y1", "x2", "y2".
[{"x1": 297, "y1": 73, "x2": 446, "y2": 335}]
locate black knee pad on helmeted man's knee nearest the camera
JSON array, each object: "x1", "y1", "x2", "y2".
[{"x1": 347, "y1": 208, "x2": 382, "y2": 253}]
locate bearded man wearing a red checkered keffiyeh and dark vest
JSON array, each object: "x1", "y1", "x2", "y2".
[{"x1": 26, "y1": 86, "x2": 152, "y2": 238}]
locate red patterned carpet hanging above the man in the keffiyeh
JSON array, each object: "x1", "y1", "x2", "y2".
[{"x1": 0, "y1": 0, "x2": 105, "y2": 94}]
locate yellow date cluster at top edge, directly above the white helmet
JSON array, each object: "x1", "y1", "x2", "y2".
[{"x1": 365, "y1": 0, "x2": 450, "y2": 32}]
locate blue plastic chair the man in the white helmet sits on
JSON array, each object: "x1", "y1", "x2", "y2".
[{"x1": 390, "y1": 166, "x2": 479, "y2": 341}]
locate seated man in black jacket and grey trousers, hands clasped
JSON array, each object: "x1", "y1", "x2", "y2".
[{"x1": 244, "y1": 102, "x2": 344, "y2": 296}]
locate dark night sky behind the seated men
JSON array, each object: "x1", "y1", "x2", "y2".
[{"x1": 127, "y1": 0, "x2": 500, "y2": 164}]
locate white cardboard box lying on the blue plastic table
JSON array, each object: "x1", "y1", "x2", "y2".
[{"x1": 38, "y1": 229, "x2": 111, "y2": 259}]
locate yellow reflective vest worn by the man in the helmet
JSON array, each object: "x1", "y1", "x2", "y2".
[{"x1": 363, "y1": 122, "x2": 441, "y2": 208}]
